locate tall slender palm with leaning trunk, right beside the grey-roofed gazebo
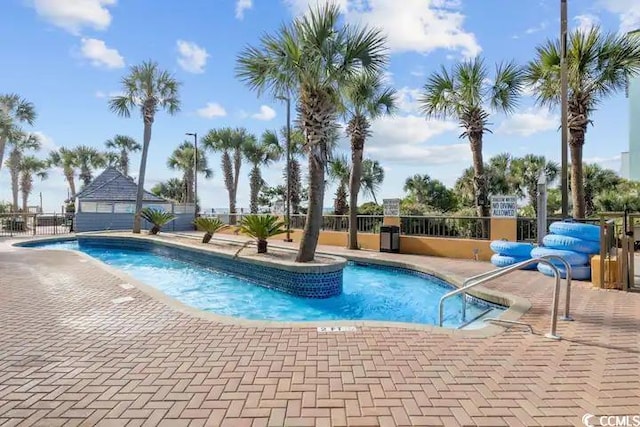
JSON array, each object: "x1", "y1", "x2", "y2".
[{"x1": 109, "y1": 61, "x2": 180, "y2": 234}]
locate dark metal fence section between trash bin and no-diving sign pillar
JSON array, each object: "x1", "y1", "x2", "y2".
[{"x1": 400, "y1": 216, "x2": 491, "y2": 240}]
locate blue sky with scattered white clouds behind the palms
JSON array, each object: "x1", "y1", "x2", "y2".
[{"x1": 0, "y1": 0, "x2": 640, "y2": 211}]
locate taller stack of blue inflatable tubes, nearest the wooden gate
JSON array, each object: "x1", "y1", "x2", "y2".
[{"x1": 531, "y1": 221, "x2": 600, "y2": 280}]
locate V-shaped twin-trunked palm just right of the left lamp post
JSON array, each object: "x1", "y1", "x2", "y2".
[{"x1": 202, "y1": 128, "x2": 255, "y2": 225}]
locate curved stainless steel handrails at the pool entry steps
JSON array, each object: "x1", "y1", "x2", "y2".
[{"x1": 438, "y1": 255, "x2": 573, "y2": 340}]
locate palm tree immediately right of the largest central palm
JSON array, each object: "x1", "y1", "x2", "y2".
[{"x1": 344, "y1": 73, "x2": 395, "y2": 249}]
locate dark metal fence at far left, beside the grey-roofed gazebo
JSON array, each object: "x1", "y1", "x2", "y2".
[{"x1": 0, "y1": 213, "x2": 73, "y2": 237}]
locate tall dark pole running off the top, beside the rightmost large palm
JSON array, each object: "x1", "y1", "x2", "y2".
[{"x1": 560, "y1": 0, "x2": 569, "y2": 218}]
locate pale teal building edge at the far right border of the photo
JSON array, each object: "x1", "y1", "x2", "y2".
[{"x1": 620, "y1": 30, "x2": 640, "y2": 181}]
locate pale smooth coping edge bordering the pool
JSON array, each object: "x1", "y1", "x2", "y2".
[{"x1": 8, "y1": 232, "x2": 531, "y2": 338}]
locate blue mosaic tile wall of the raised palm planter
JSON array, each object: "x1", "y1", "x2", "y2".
[{"x1": 78, "y1": 236, "x2": 342, "y2": 298}]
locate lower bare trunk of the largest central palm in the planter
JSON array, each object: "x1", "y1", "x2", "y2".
[{"x1": 296, "y1": 152, "x2": 325, "y2": 262}]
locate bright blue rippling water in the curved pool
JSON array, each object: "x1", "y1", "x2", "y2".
[{"x1": 26, "y1": 240, "x2": 500, "y2": 327}]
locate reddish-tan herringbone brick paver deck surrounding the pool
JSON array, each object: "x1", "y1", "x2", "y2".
[{"x1": 0, "y1": 237, "x2": 640, "y2": 426}]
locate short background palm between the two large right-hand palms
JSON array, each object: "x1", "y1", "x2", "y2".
[{"x1": 511, "y1": 154, "x2": 560, "y2": 214}]
